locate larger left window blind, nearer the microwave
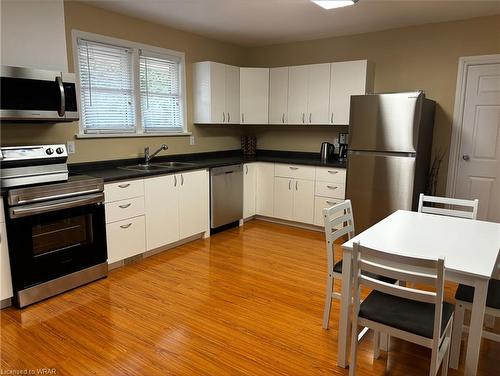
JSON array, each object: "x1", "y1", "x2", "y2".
[{"x1": 78, "y1": 39, "x2": 135, "y2": 133}]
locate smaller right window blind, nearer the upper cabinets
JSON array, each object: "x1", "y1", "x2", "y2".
[{"x1": 139, "y1": 51, "x2": 183, "y2": 132}]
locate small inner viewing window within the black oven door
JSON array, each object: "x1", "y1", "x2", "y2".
[{"x1": 31, "y1": 214, "x2": 92, "y2": 257}]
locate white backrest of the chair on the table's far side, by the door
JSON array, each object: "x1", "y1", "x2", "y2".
[{"x1": 417, "y1": 193, "x2": 479, "y2": 219}]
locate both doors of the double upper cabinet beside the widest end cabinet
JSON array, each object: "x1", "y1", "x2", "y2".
[{"x1": 288, "y1": 64, "x2": 330, "y2": 124}]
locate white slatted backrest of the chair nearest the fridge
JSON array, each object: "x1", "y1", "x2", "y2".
[{"x1": 323, "y1": 200, "x2": 354, "y2": 271}]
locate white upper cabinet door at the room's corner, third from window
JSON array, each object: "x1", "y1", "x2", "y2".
[{"x1": 240, "y1": 68, "x2": 269, "y2": 124}]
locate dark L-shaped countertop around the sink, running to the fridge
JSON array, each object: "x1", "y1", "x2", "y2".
[{"x1": 69, "y1": 150, "x2": 346, "y2": 182}]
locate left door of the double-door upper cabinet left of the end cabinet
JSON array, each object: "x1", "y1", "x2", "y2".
[{"x1": 288, "y1": 65, "x2": 309, "y2": 124}]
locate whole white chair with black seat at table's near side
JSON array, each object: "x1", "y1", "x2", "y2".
[{"x1": 349, "y1": 242, "x2": 453, "y2": 376}]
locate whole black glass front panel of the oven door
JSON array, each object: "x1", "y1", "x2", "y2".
[{"x1": 7, "y1": 204, "x2": 107, "y2": 290}]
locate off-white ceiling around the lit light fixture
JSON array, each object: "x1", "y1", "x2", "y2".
[{"x1": 85, "y1": 0, "x2": 500, "y2": 46}]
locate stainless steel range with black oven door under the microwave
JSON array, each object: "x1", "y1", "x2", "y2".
[{"x1": 0, "y1": 145, "x2": 108, "y2": 307}]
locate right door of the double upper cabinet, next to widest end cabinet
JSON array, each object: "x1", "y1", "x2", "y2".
[{"x1": 306, "y1": 64, "x2": 331, "y2": 124}]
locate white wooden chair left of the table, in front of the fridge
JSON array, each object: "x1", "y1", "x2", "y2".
[{"x1": 323, "y1": 200, "x2": 395, "y2": 328}]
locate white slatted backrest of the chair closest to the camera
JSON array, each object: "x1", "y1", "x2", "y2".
[{"x1": 353, "y1": 242, "x2": 444, "y2": 340}]
